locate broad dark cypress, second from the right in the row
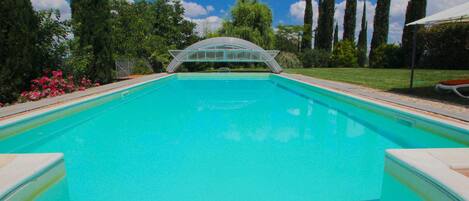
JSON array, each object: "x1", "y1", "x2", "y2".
[{"x1": 370, "y1": 0, "x2": 391, "y2": 67}]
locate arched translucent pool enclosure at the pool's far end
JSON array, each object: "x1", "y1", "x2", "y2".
[{"x1": 166, "y1": 37, "x2": 282, "y2": 73}]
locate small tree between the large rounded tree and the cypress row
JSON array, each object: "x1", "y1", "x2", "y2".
[{"x1": 275, "y1": 24, "x2": 303, "y2": 53}]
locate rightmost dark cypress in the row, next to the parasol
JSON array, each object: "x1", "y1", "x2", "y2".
[{"x1": 402, "y1": 0, "x2": 427, "y2": 66}]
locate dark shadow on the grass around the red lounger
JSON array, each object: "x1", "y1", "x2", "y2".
[{"x1": 389, "y1": 86, "x2": 469, "y2": 107}]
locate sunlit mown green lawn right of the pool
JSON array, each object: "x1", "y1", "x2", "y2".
[{"x1": 285, "y1": 68, "x2": 469, "y2": 90}]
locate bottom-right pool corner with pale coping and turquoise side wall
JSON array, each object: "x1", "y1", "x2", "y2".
[{"x1": 382, "y1": 148, "x2": 469, "y2": 200}]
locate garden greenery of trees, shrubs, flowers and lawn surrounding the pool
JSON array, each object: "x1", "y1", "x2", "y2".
[{"x1": 0, "y1": 0, "x2": 469, "y2": 107}]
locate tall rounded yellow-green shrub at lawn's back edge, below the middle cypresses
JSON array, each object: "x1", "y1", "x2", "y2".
[{"x1": 330, "y1": 40, "x2": 358, "y2": 67}]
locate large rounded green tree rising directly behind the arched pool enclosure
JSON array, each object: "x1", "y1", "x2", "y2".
[{"x1": 219, "y1": 0, "x2": 275, "y2": 49}]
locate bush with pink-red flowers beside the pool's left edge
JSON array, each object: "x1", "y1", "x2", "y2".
[{"x1": 19, "y1": 70, "x2": 99, "y2": 102}]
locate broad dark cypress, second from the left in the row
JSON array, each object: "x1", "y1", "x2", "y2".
[{"x1": 316, "y1": 0, "x2": 335, "y2": 51}]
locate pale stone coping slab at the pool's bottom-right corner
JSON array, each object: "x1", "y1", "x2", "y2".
[{"x1": 386, "y1": 148, "x2": 469, "y2": 200}]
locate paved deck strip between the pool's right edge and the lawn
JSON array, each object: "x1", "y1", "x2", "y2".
[{"x1": 282, "y1": 73, "x2": 469, "y2": 124}]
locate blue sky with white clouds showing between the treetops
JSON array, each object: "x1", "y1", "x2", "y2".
[{"x1": 31, "y1": 0, "x2": 468, "y2": 43}]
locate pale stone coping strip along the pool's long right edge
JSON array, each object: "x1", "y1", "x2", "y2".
[{"x1": 274, "y1": 73, "x2": 469, "y2": 130}]
